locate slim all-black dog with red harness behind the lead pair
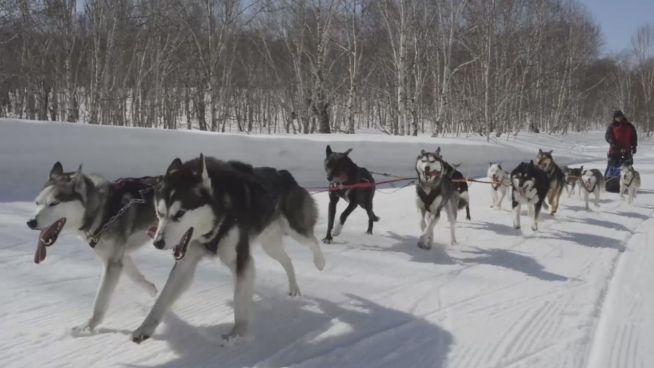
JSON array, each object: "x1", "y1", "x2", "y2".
[{"x1": 322, "y1": 145, "x2": 379, "y2": 244}]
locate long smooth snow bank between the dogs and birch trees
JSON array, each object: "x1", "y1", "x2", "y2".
[{"x1": 0, "y1": 119, "x2": 599, "y2": 202}]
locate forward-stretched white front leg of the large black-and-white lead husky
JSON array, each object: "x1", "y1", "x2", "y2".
[{"x1": 132, "y1": 244, "x2": 204, "y2": 344}]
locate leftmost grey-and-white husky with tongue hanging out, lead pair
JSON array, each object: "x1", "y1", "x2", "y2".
[{"x1": 27, "y1": 162, "x2": 160, "y2": 333}]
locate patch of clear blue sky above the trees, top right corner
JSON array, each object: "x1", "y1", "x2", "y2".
[{"x1": 580, "y1": 0, "x2": 654, "y2": 53}]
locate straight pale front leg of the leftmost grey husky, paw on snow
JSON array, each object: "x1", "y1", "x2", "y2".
[{"x1": 73, "y1": 258, "x2": 123, "y2": 333}]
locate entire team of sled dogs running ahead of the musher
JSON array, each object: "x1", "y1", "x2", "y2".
[{"x1": 27, "y1": 146, "x2": 640, "y2": 343}]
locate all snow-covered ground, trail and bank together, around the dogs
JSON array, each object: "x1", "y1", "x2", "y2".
[{"x1": 0, "y1": 119, "x2": 654, "y2": 368}]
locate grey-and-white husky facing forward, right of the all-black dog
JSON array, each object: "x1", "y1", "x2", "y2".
[{"x1": 415, "y1": 150, "x2": 461, "y2": 249}]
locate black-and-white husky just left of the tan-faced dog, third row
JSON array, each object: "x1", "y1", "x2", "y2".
[{"x1": 511, "y1": 161, "x2": 550, "y2": 231}]
